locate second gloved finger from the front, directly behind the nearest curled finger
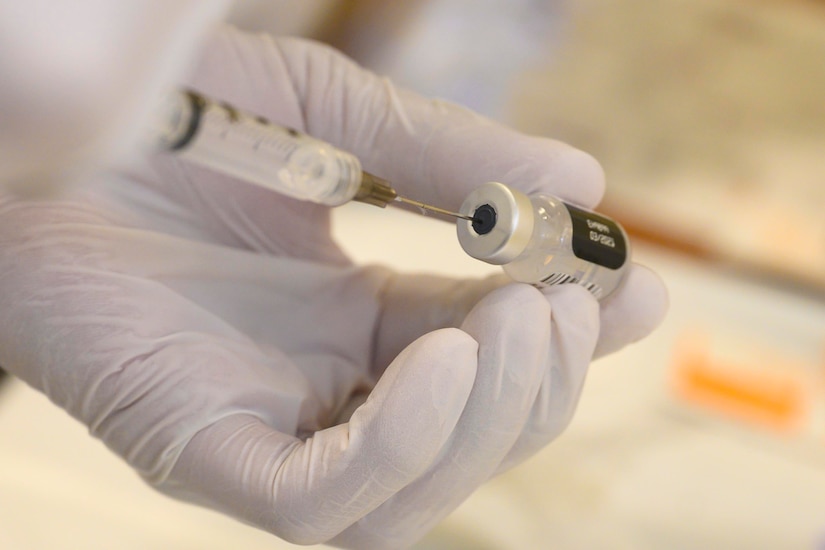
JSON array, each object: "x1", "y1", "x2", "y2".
[{"x1": 334, "y1": 285, "x2": 551, "y2": 549}]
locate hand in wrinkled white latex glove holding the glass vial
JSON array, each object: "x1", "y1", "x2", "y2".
[{"x1": 0, "y1": 24, "x2": 666, "y2": 548}]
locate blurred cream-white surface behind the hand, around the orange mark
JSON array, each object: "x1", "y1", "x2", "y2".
[{"x1": 0, "y1": 205, "x2": 825, "y2": 550}]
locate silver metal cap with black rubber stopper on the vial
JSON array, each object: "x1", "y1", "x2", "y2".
[{"x1": 456, "y1": 182, "x2": 533, "y2": 265}]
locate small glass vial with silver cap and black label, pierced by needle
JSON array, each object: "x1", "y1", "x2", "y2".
[{"x1": 458, "y1": 182, "x2": 630, "y2": 299}]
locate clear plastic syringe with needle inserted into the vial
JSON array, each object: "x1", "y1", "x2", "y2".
[{"x1": 153, "y1": 91, "x2": 472, "y2": 221}]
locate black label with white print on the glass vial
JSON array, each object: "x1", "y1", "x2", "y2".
[{"x1": 565, "y1": 203, "x2": 627, "y2": 269}]
